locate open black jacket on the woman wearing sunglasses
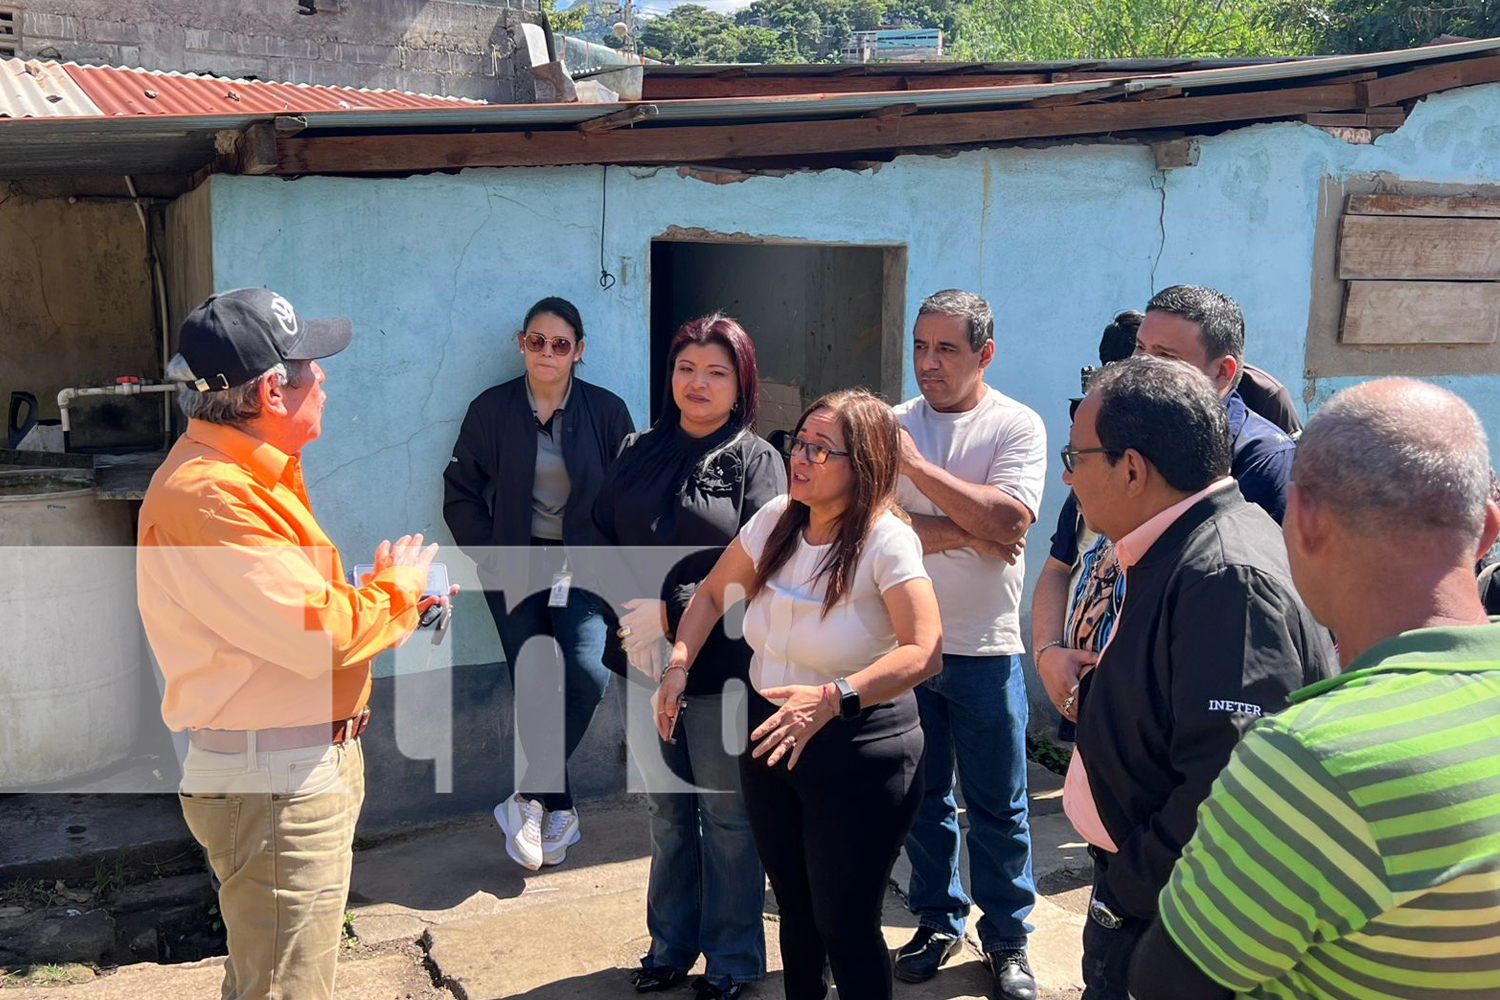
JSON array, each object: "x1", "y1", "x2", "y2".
[{"x1": 443, "y1": 375, "x2": 635, "y2": 571}]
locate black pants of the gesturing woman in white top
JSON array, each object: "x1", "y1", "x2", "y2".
[{"x1": 740, "y1": 694, "x2": 923, "y2": 1000}]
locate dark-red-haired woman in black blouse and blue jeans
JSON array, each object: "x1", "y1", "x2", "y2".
[{"x1": 594, "y1": 313, "x2": 786, "y2": 1000}]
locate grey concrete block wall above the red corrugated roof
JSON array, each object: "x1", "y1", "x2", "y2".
[{"x1": 11, "y1": 0, "x2": 540, "y2": 103}]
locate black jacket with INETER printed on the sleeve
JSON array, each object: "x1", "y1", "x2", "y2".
[{"x1": 1077, "y1": 490, "x2": 1338, "y2": 918}]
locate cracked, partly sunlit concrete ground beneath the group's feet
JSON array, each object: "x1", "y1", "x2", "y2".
[{"x1": 9, "y1": 766, "x2": 1088, "y2": 1000}]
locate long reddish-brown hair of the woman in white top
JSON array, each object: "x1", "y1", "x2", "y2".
[{"x1": 750, "y1": 388, "x2": 902, "y2": 616}]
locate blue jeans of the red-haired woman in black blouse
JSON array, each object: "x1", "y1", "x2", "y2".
[{"x1": 645, "y1": 694, "x2": 765, "y2": 987}]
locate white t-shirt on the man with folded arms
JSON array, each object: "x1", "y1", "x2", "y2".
[{"x1": 896, "y1": 388, "x2": 1047, "y2": 657}]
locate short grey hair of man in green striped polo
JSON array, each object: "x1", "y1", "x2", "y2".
[{"x1": 1292, "y1": 378, "x2": 1490, "y2": 546}]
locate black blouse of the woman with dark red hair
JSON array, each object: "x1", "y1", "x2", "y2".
[{"x1": 594, "y1": 423, "x2": 786, "y2": 697}]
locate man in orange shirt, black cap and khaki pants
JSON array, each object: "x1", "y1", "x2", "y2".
[{"x1": 137, "y1": 288, "x2": 450, "y2": 1000}]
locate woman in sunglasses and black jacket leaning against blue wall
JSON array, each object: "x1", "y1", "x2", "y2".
[{"x1": 443, "y1": 297, "x2": 635, "y2": 870}]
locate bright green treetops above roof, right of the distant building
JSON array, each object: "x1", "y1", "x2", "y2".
[{"x1": 954, "y1": 0, "x2": 1307, "y2": 61}]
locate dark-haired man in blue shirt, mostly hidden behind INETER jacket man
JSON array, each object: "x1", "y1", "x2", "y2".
[{"x1": 1136, "y1": 285, "x2": 1296, "y2": 523}]
